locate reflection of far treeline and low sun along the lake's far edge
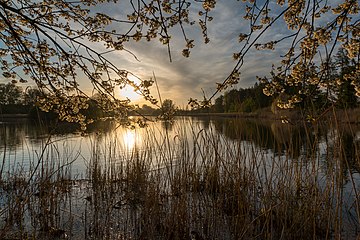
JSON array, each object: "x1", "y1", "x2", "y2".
[{"x1": 0, "y1": 117, "x2": 360, "y2": 172}]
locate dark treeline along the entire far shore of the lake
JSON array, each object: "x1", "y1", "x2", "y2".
[{"x1": 0, "y1": 49, "x2": 360, "y2": 119}]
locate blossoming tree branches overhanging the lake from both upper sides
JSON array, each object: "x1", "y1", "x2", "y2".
[{"x1": 0, "y1": 0, "x2": 360, "y2": 121}]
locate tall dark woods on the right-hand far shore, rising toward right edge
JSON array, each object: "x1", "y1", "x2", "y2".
[{"x1": 192, "y1": 48, "x2": 360, "y2": 114}]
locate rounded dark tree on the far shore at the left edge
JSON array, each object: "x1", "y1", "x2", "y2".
[{"x1": 0, "y1": 83, "x2": 23, "y2": 105}]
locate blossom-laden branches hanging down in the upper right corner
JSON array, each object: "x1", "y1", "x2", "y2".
[{"x1": 259, "y1": 0, "x2": 360, "y2": 108}]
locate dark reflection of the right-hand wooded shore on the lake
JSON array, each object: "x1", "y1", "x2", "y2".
[{"x1": 191, "y1": 118, "x2": 360, "y2": 172}]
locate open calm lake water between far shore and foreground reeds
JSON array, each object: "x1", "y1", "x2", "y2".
[{"x1": 0, "y1": 117, "x2": 360, "y2": 180}]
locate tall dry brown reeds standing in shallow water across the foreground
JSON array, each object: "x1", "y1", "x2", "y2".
[{"x1": 0, "y1": 116, "x2": 360, "y2": 239}]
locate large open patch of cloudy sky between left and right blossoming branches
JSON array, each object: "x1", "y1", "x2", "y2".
[{"x1": 104, "y1": 1, "x2": 250, "y2": 104}]
